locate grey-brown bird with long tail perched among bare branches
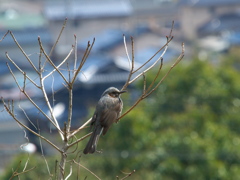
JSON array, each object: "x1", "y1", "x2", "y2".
[{"x1": 83, "y1": 87, "x2": 126, "y2": 154}]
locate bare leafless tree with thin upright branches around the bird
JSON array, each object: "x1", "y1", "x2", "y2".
[{"x1": 1, "y1": 19, "x2": 184, "y2": 180}]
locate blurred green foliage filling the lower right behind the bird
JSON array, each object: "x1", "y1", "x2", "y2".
[{"x1": 3, "y1": 56, "x2": 240, "y2": 180}]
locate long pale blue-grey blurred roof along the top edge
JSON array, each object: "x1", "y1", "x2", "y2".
[{"x1": 44, "y1": 0, "x2": 132, "y2": 20}]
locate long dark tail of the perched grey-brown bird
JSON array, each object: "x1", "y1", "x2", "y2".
[{"x1": 83, "y1": 126, "x2": 103, "y2": 154}]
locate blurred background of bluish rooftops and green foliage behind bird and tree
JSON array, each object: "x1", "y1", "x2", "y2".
[{"x1": 0, "y1": 0, "x2": 240, "y2": 180}]
